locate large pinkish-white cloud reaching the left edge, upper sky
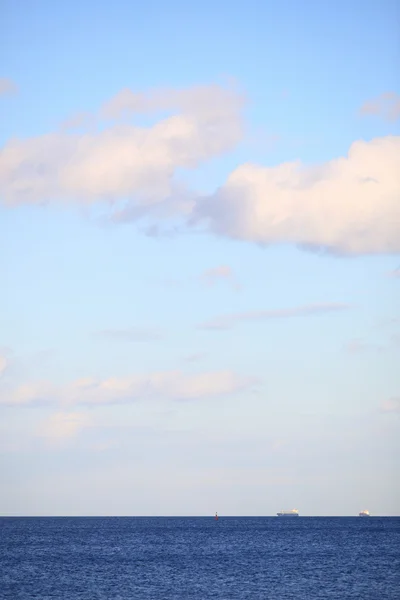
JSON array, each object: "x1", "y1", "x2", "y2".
[{"x1": 0, "y1": 85, "x2": 244, "y2": 213}]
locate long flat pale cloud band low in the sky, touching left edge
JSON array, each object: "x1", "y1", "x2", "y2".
[{"x1": 0, "y1": 371, "x2": 256, "y2": 406}]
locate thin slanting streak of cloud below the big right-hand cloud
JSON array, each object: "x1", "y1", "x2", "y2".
[{"x1": 199, "y1": 302, "x2": 350, "y2": 329}]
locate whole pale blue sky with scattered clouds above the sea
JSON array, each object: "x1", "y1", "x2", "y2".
[{"x1": 0, "y1": 0, "x2": 400, "y2": 516}]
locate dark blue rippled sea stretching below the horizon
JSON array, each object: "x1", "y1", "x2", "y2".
[{"x1": 0, "y1": 516, "x2": 400, "y2": 600}]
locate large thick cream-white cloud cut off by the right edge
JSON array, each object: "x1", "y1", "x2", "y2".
[{"x1": 190, "y1": 136, "x2": 400, "y2": 255}]
